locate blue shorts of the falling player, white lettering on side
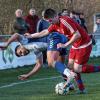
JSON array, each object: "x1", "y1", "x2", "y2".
[{"x1": 47, "y1": 32, "x2": 68, "y2": 55}]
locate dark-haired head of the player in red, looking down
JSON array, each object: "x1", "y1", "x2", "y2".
[{"x1": 44, "y1": 8, "x2": 59, "y2": 24}]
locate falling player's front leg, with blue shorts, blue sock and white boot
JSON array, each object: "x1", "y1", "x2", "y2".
[{"x1": 47, "y1": 32, "x2": 73, "y2": 87}]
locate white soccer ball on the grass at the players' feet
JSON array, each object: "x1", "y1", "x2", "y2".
[{"x1": 55, "y1": 82, "x2": 69, "y2": 95}]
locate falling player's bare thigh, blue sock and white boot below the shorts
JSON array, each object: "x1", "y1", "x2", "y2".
[{"x1": 47, "y1": 51, "x2": 75, "y2": 84}]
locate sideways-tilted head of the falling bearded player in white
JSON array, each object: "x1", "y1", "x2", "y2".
[{"x1": 15, "y1": 45, "x2": 30, "y2": 57}]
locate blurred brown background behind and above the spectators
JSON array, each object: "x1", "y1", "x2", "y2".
[{"x1": 0, "y1": 0, "x2": 100, "y2": 34}]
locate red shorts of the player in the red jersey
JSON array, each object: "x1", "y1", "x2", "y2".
[{"x1": 69, "y1": 45, "x2": 92, "y2": 65}]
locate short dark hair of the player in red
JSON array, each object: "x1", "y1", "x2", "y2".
[{"x1": 44, "y1": 8, "x2": 57, "y2": 19}]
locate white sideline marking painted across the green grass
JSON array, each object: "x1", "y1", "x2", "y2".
[{"x1": 0, "y1": 76, "x2": 61, "y2": 89}]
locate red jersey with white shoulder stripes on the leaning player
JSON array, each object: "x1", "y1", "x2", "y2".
[{"x1": 48, "y1": 16, "x2": 90, "y2": 48}]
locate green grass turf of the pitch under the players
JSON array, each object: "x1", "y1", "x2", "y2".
[{"x1": 0, "y1": 57, "x2": 100, "y2": 100}]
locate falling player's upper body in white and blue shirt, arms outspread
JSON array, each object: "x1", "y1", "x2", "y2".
[{"x1": 0, "y1": 33, "x2": 47, "y2": 80}]
